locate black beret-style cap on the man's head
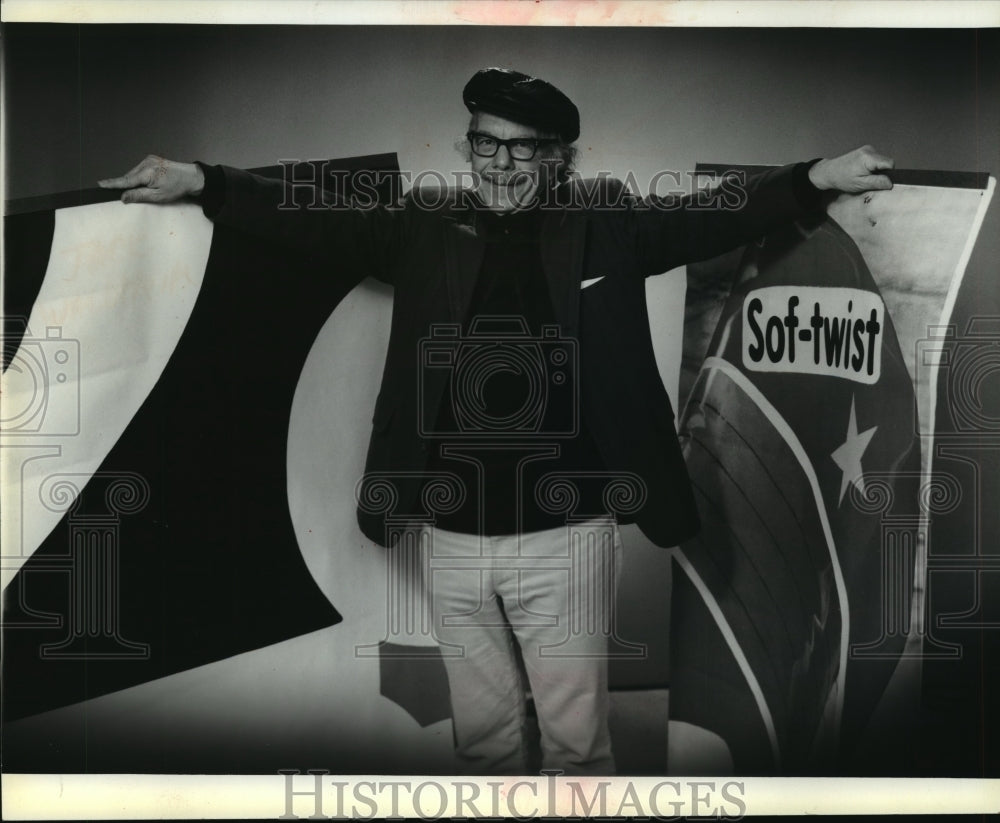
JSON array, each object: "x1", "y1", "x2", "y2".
[{"x1": 462, "y1": 69, "x2": 580, "y2": 143}]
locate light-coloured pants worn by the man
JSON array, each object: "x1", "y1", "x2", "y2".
[{"x1": 424, "y1": 520, "x2": 621, "y2": 774}]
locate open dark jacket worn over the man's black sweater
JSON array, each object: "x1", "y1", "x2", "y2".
[{"x1": 213, "y1": 164, "x2": 818, "y2": 546}]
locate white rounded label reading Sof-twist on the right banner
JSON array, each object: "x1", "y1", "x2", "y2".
[{"x1": 743, "y1": 286, "x2": 885, "y2": 384}]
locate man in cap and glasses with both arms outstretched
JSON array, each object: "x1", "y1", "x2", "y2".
[{"x1": 101, "y1": 68, "x2": 892, "y2": 774}]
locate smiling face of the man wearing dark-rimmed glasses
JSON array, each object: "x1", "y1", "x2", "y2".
[{"x1": 470, "y1": 112, "x2": 552, "y2": 212}]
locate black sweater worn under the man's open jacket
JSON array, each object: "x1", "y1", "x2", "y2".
[{"x1": 428, "y1": 199, "x2": 606, "y2": 535}]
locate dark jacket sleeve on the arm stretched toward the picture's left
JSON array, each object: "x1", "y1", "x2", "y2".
[{"x1": 199, "y1": 164, "x2": 406, "y2": 283}]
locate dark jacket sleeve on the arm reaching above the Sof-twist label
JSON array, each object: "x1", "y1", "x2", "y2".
[{"x1": 626, "y1": 160, "x2": 823, "y2": 276}]
